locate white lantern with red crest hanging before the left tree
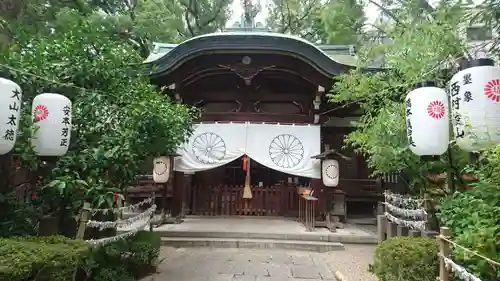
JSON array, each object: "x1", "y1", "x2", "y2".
[{"x1": 31, "y1": 93, "x2": 72, "y2": 156}]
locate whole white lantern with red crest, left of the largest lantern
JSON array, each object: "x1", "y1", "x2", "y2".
[{"x1": 405, "y1": 82, "x2": 450, "y2": 156}]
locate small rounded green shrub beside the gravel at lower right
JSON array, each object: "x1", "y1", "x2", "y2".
[{"x1": 370, "y1": 237, "x2": 439, "y2": 281}]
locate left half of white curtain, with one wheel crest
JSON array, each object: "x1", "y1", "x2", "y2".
[{"x1": 174, "y1": 123, "x2": 247, "y2": 173}]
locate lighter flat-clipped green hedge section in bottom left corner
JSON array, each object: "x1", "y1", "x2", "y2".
[{"x1": 0, "y1": 236, "x2": 88, "y2": 281}]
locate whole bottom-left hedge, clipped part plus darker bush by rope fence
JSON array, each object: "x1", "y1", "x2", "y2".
[{"x1": 0, "y1": 231, "x2": 160, "y2": 281}]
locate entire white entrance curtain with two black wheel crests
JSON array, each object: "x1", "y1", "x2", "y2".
[{"x1": 175, "y1": 123, "x2": 321, "y2": 179}]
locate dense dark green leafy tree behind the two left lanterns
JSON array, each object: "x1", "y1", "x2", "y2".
[{"x1": 0, "y1": 9, "x2": 197, "y2": 212}]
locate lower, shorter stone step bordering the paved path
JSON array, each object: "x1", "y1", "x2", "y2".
[{"x1": 161, "y1": 237, "x2": 344, "y2": 253}]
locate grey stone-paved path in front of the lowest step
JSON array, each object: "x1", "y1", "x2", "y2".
[{"x1": 143, "y1": 247, "x2": 342, "y2": 281}]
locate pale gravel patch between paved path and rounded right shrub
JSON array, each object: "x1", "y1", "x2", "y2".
[{"x1": 324, "y1": 244, "x2": 377, "y2": 281}]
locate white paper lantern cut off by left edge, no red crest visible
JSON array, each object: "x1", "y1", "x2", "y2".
[{"x1": 0, "y1": 78, "x2": 22, "y2": 155}]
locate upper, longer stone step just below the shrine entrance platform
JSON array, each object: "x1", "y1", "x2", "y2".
[{"x1": 154, "y1": 229, "x2": 377, "y2": 244}]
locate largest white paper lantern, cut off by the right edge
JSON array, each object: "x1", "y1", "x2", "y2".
[{"x1": 450, "y1": 59, "x2": 500, "y2": 151}]
